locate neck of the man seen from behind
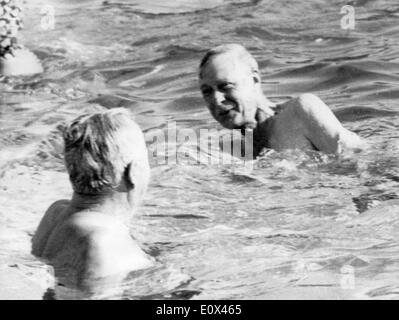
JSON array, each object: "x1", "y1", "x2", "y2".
[{"x1": 69, "y1": 192, "x2": 134, "y2": 220}]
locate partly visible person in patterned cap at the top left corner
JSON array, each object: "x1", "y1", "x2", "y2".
[{"x1": 0, "y1": 0, "x2": 43, "y2": 76}]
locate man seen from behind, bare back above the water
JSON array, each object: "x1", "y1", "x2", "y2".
[{"x1": 32, "y1": 109, "x2": 152, "y2": 289}]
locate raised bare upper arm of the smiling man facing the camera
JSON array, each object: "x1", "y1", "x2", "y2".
[{"x1": 294, "y1": 93, "x2": 364, "y2": 153}]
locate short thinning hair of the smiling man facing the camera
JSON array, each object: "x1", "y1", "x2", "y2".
[{"x1": 199, "y1": 43, "x2": 259, "y2": 79}]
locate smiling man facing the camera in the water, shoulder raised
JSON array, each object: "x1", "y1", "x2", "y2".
[{"x1": 199, "y1": 44, "x2": 363, "y2": 155}]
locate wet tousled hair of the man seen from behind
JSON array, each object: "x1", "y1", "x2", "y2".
[{"x1": 64, "y1": 108, "x2": 148, "y2": 194}]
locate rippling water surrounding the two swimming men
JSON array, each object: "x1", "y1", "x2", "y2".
[{"x1": 0, "y1": 0, "x2": 399, "y2": 299}]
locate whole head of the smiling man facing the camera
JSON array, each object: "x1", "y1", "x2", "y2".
[{"x1": 199, "y1": 44, "x2": 264, "y2": 129}]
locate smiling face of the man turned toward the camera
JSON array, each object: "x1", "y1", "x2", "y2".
[{"x1": 200, "y1": 54, "x2": 260, "y2": 129}]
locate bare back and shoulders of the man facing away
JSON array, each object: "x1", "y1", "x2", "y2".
[{"x1": 32, "y1": 202, "x2": 152, "y2": 287}]
